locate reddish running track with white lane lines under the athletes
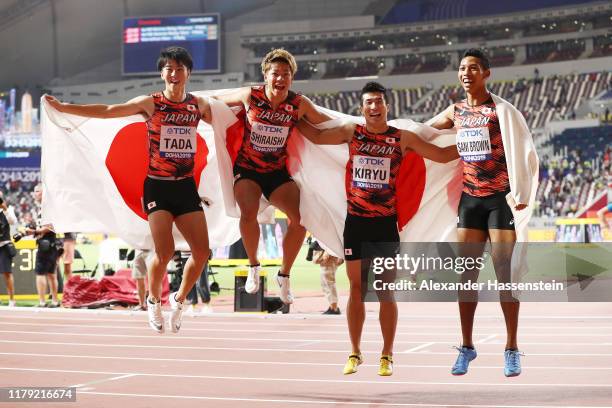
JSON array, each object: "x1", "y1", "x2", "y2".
[{"x1": 0, "y1": 303, "x2": 612, "y2": 408}]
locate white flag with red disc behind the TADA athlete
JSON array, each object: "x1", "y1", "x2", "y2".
[{"x1": 41, "y1": 99, "x2": 240, "y2": 250}]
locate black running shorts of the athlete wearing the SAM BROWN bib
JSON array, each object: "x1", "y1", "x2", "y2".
[{"x1": 457, "y1": 191, "x2": 514, "y2": 231}]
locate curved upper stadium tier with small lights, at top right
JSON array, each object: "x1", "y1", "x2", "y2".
[{"x1": 241, "y1": 0, "x2": 612, "y2": 79}]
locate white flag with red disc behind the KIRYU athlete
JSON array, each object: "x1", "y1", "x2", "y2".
[{"x1": 210, "y1": 99, "x2": 462, "y2": 257}]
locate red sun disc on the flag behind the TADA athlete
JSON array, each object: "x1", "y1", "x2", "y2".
[{"x1": 105, "y1": 122, "x2": 208, "y2": 220}]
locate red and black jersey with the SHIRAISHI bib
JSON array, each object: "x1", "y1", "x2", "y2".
[{"x1": 234, "y1": 86, "x2": 302, "y2": 173}]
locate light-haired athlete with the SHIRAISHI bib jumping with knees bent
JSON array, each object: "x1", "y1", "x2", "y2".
[{"x1": 216, "y1": 49, "x2": 330, "y2": 304}]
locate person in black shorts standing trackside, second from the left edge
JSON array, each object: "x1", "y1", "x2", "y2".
[{"x1": 26, "y1": 184, "x2": 60, "y2": 307}]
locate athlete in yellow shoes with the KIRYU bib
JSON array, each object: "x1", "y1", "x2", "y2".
[{"x1": 298, "y1": 82, "x2": 458, "y2": 375}]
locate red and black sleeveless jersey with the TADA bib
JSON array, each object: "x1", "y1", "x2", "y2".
[{"x1": 147, "y1": 92, "x2": 202, "y2": 177}]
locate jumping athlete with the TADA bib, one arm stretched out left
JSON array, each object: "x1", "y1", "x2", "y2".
[{"x1": 45, "y1": 47, "x2": 211, "y2": 333}]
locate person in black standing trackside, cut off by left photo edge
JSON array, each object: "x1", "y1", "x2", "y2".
[{"x1": 0, "y1": 192, "x2": 17, "y2": 307}]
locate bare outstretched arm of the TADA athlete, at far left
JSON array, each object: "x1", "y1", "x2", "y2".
[{"x1": 44, "y1": 95, "x2": 155, "y2": 119}]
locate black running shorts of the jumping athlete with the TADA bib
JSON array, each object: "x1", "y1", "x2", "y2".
[{"x1": 143, "y1": 177, "x2": 203, "y2": 217}]
